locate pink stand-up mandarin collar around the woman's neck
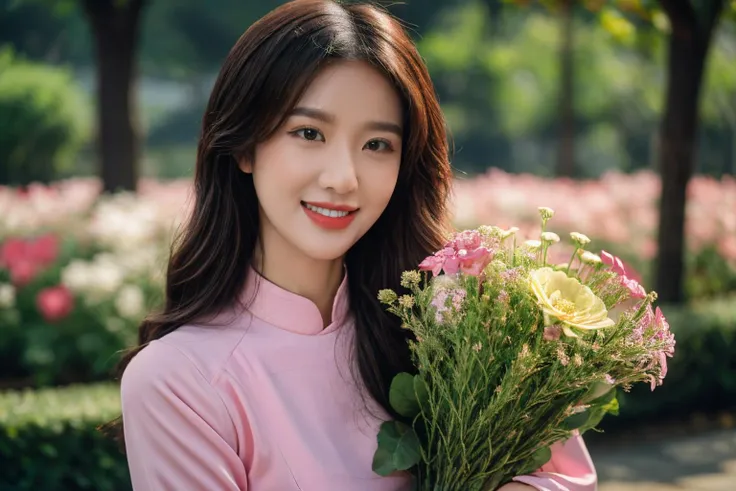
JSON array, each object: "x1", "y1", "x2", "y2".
[{"x1": 243, "y1": 266, "x2": 349, "y2": 336}]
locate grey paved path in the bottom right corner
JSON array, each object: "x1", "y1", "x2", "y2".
[{"x1": 590, "y1": 429, "x2": 736, "y2": 491}]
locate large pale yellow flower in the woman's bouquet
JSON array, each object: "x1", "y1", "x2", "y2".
[{"x1": 531, "y1": 268, "x2": 615, "y2": 337}]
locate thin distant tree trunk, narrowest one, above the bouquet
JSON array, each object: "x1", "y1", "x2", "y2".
[{"x1": 556, "y1": 0, "x2": 575, "y2": 177}]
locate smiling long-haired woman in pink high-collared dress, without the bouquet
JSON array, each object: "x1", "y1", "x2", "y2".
[{"x1": 116, "y1": 0, "x2": 596, "y2": 491}]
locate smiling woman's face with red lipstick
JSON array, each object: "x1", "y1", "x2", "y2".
[{"x1": 240, "y1": 61, "x2": 402, "y2": 266}]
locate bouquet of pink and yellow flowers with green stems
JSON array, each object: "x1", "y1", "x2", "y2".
[{"x1": 373, "y1": 208, "x2": 675, "y2": 491}]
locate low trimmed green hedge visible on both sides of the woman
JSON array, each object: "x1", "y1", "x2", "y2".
[{"x1": 0, "y1": 299, "x2": 736, "y2": 491}]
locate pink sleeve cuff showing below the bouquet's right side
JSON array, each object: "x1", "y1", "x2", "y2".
[{"x1": 514, "y1": 434, "x2": 598, "y2": 491}]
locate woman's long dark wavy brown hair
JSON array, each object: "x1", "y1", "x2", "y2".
[{"x1": 105, "y1": 0, "x2": 452, "y2": 444}]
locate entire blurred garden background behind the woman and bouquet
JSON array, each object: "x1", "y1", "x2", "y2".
[{"x1": 0, "y1": 0, "x2": 736, "y2": 491}]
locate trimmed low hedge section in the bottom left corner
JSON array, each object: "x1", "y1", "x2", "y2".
[{"x1": 0, "y1": 385, "x2": 131, "y2": 491}]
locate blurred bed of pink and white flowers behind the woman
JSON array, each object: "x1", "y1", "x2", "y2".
[{"x1": 0, "y1": 171, "x2": 736, "y2": 387}]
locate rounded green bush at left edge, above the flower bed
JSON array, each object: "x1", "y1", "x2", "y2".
[{"x1": 0, "y1": 51, "x2": 89, "y2": 185}]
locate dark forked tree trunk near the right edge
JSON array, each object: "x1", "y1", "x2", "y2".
[{"x1": 655, "y1": 0, "x2": 723, "y2": 303}]
